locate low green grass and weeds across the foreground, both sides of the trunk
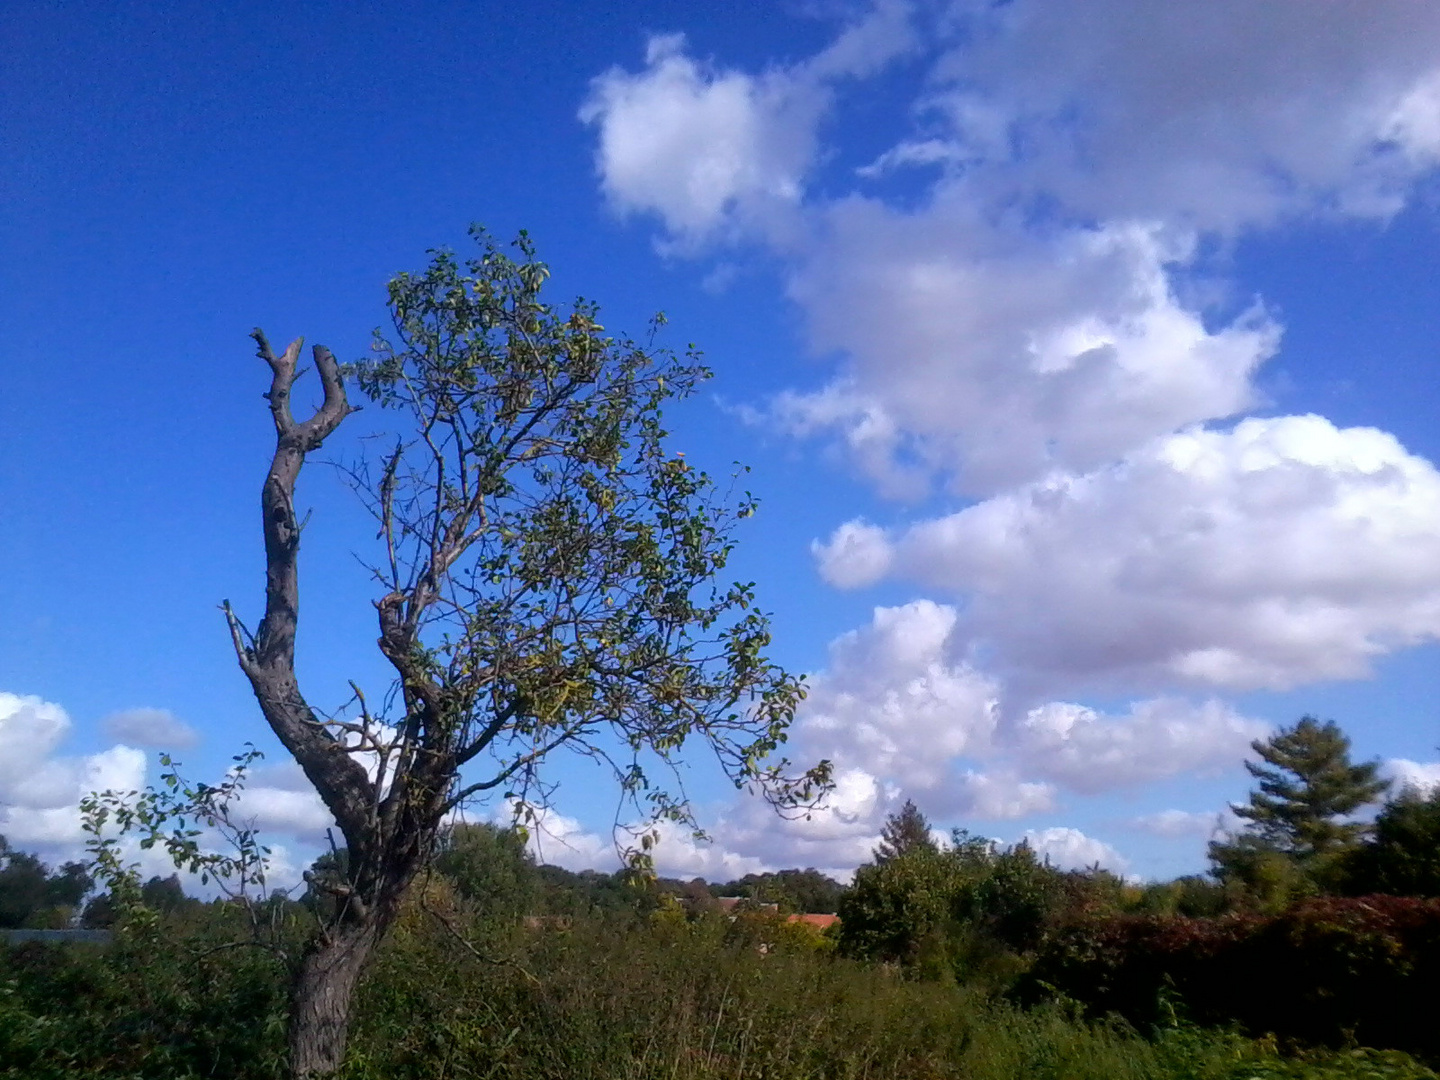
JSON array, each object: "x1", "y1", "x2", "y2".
[{"x1": 0, "y1": 904, "x2": 1434, "y2": 1080}]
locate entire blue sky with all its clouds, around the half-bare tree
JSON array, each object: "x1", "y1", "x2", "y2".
[{"x1": 0, "y1": 0, "x2": 1440, "y2": 878}]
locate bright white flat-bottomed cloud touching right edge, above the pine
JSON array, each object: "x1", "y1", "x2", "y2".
[{"x1": 821, "y1": 416, "x2": 1440, "y2": 690}]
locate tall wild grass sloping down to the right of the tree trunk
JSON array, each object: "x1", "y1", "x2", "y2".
[{"x1": 339, "y1": 919, "x2": 1434, "y2": 1080}]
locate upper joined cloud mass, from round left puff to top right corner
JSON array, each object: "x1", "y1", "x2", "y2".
[{"x1": 583, "y1": 0, "x2": 1440, "y2": 498}]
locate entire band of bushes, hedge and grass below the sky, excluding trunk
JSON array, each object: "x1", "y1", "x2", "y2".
[{"x1": 8, "y1": 754, "x2": 1440, "y2": 1080}]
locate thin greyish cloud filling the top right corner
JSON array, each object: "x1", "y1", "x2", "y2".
[{"x1": 924, "y1": 0, "x2": 1440, "y2": 229}]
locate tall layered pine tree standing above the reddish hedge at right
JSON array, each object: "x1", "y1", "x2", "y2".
[{"x1": 1231, "y1": 716, "x2": 1390, "y2": 863}]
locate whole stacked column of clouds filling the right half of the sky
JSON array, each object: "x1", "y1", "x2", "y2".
[{"x1": 567, "y1": 0, "x2": 1440, "y2": 867}]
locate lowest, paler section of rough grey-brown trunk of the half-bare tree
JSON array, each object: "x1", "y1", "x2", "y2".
[{"x1": 289, "y1": 920, "x2": 380, "y2": 1080}]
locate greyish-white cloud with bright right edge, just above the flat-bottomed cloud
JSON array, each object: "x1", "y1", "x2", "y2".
[{"x1": 772, "y1": 210, "x2": 1279, "y2": 497}]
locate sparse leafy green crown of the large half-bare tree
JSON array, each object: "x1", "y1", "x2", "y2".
[{"x1": 351, "y1": 229, "x2": 829, "y2": 835}]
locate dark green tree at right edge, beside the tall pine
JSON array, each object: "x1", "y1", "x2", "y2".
[{"x1": 1342, "y1": 786, "x2": 1440, "y2": 897}]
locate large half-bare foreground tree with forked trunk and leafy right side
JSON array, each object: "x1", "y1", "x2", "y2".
[{"x1": 225, "y1": 230, "x2": 828, "y2": 1076}]
